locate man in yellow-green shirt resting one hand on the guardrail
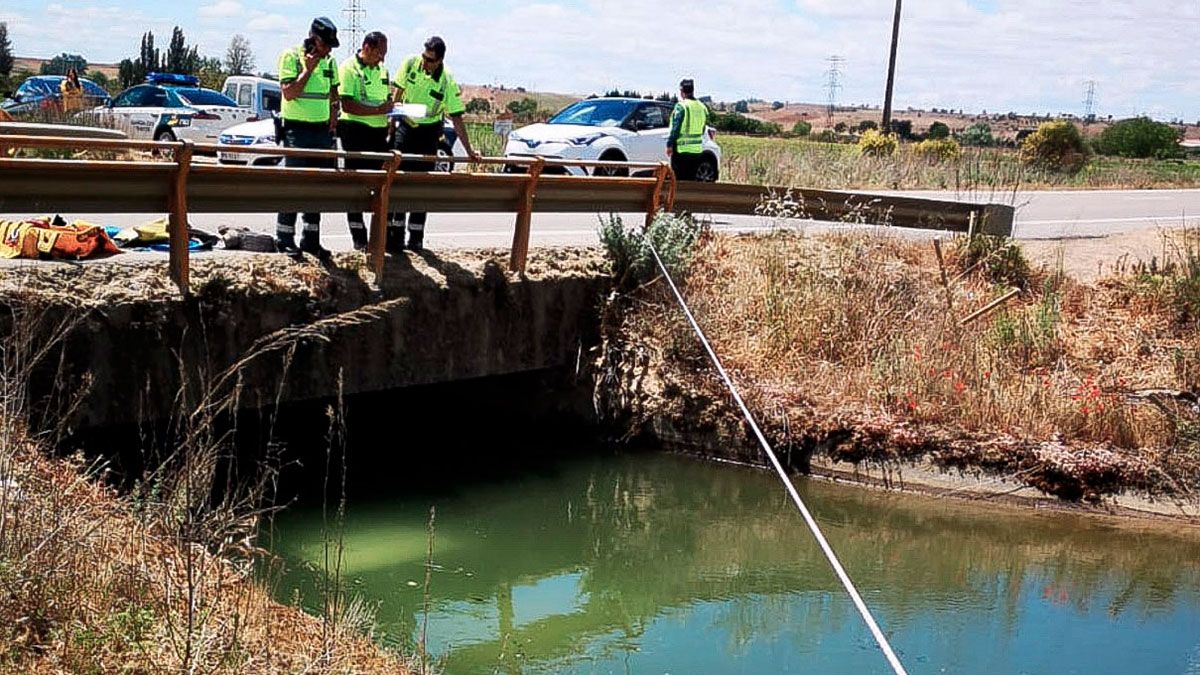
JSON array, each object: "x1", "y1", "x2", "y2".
[{"x1": 388, "y1": 37, "x2": 479, "y2": 253}]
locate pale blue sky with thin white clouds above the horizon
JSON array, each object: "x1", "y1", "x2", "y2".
[{"x1": 0, "y1": 0, "x2": 1200, "y2": 123}]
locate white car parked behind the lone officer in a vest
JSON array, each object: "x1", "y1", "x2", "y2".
[{"x1": 504, "y1": 98, "x2": 721, "y2": 181}]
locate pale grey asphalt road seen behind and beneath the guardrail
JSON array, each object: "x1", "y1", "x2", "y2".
[{"x1": 4, "y1": 190, "x2": 1200, "y2": 250}]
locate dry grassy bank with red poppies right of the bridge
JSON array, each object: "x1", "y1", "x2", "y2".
[{"x1": 624, "y1": 225, "x2": 1200, "y2": 498}]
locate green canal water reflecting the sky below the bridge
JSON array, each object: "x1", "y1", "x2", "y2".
[{"x1": 276, "y1": 455, "x2": 1200, "y2": 675}]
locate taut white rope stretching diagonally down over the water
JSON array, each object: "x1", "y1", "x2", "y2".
[{"x1": 646, "y1": 237, "x2": 908, "y2": 675}]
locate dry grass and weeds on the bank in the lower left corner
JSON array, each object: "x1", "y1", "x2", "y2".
[{"x1": 0, "y1": 302, "x2": 408, "y2": 674}]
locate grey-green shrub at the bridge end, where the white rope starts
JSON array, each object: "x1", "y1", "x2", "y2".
[{"x1": 600, "y1": 207, "x2": 708, "y2": 285}]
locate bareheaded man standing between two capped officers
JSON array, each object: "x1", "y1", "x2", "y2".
[{"x1": 337, "y1": 32, "x2": 392, "y2": 251}]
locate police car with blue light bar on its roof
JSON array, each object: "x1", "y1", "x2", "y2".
[{"x1": 90, "y1": 73, "x2": 254, "y2": 143}]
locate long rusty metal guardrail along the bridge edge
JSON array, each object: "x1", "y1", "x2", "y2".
[{"x1": 0, "y1": 135, "x2": 1013, "y2": 293}]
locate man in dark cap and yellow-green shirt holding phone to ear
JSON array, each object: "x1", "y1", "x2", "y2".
[{"x1": 275, "y1": 17, "x2": 340, "y2": 263}]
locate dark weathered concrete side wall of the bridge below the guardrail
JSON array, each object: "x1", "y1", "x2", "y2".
[{"x1": 6, "y1": 249, "x2": 608, "y2": 430}]
